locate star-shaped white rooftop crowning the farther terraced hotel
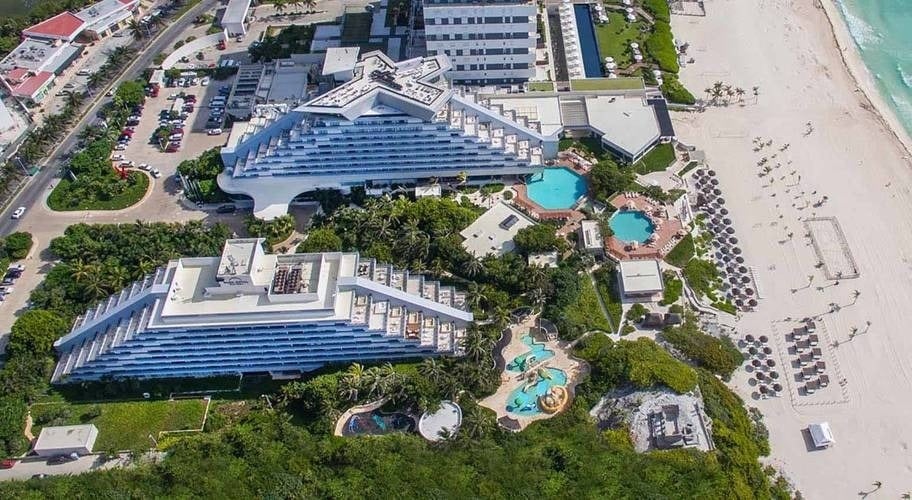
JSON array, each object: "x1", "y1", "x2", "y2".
[{"x1": 298, "y1": 51, "x2": 451, "y2": 119}]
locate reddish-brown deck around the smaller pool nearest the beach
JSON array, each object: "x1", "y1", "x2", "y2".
[{"x1": 605, "y1": 193, "x2": 686, "y2": 260}]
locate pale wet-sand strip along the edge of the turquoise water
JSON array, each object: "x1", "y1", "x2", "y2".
[{"x1": 814, "y1": 0, "x2": 912, "y2": 158}]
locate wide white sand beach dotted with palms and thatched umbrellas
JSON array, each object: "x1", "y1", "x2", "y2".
[{"x1": 673, "y1": 0, "x2": 912, "y2": 498}]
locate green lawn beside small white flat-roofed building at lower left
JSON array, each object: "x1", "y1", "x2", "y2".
[{"x1": 31, "y1": 399, "x2": 206, "y2": 451}]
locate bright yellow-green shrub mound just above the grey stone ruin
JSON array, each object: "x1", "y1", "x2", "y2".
[{"x1": 574, "y1": 335, "x2": 697, "y2": 399}]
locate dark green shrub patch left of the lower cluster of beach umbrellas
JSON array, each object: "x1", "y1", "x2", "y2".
[{"x1": 662, "y1": 315, "x2": 744, "y2": 380}]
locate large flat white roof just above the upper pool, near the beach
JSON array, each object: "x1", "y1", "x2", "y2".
[{"x1": 586, "y1": 96, "x2": 659, "y2": 156}]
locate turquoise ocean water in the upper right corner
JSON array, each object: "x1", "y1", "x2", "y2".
[{"x1": 836, "y1": 0, "x2": 912, "y2": 139}]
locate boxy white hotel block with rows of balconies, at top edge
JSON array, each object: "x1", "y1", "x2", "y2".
[{"x1": 424, "y1": 0, "x2": 538, "y2": 85}]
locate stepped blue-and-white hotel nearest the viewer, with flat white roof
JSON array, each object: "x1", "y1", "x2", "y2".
[{"x1": 52, "y1": 238, "x2": 472, "y2": 383}]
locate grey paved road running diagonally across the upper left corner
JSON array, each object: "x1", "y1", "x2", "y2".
[{"x1": 0, "y1": 0, "x2": 218, "y2": 236}]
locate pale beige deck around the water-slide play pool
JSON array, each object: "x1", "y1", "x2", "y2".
[{"x1": 478, "y1": 316, "x2": 587, "y2": 431}]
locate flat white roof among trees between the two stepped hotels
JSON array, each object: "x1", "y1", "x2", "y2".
[{"x1": 459, "y1": 202, "x2": 535, "y2": 257}]
